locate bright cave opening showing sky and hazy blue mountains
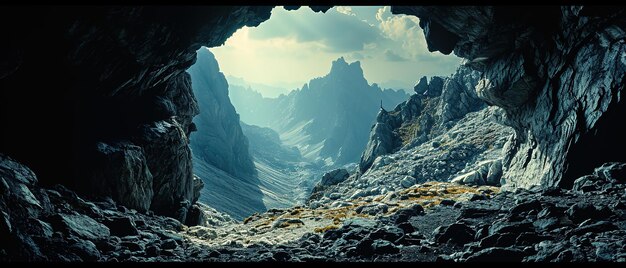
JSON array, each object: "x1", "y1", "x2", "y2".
[{"x1": 188, "y1": 6, "x2": 460, "y2": 222}]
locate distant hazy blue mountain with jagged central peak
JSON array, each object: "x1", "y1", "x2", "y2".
[{"x1": 231, "y1": 57, "x2": 408, "y2": 165}]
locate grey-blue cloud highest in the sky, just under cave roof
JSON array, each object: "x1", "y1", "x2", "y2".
[{"x1": 250, "y1": 8, "x2": 383, "y2": 52}]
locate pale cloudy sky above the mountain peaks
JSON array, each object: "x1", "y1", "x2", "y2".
[{"x1": 210, "y1": 6, "x2": 461, "y2": 97}]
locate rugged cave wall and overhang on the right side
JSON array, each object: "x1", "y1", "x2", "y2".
[{"x1": 392, "y1": 6, "x2": 626, "y2": 191}]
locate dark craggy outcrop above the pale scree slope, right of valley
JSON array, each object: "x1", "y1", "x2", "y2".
[{"x1": 359, "y1": 67, "x2": 486, "y2": 173}]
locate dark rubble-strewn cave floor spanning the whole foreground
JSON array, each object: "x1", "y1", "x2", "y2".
[{"x1": 0, "y1": 153, "x2": 626, "y2": 261}]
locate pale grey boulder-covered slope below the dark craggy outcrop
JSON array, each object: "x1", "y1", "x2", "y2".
[{"x1": 309, "y1": 107, "x2": 513, "y2": 207}]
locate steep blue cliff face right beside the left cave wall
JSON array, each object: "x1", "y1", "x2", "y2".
[{"x1": 187, "y1": 48, "x2": 256, "y2": 179}]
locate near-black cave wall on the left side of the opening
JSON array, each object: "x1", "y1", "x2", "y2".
[{"x1": 0, "y1": 6, "x2": 272, "y2": 220}]
